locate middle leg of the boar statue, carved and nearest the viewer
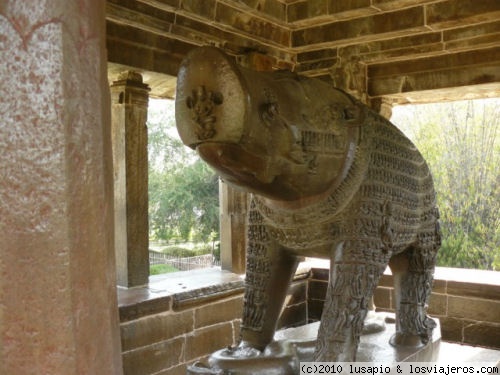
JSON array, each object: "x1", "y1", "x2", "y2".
[{"x1": 314, "y1": 241, "x2": 388, "y2": 362}]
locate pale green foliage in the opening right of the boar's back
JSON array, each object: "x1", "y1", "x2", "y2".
[{"x1": 391, "y1": 100, "x2": 500, "y2": 270}]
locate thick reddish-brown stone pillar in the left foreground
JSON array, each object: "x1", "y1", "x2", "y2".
[{"x1": 0, "y1": 0, "x2": 122, "y2": 375}]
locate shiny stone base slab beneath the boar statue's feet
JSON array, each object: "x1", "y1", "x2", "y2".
[{"x1": 187, "y1": 314, "x2": 441, "y2": 375}]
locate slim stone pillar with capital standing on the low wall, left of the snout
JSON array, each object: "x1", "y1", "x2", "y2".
[{"x1": 111, "y1": 71, "x2": 149, "y2": 287}]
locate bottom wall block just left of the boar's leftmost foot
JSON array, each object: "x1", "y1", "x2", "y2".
[{"x1": 185, "y1": 323, "x2": 235, "y2": 361}]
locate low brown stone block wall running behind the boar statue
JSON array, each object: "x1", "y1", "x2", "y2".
[{"x1": 119, "y1": 265, "x2": 500, "y2": 375}]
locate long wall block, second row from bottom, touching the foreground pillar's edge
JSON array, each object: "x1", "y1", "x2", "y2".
[{"x1": 120, "y1": 311, "x2": 194, "y2": 351}]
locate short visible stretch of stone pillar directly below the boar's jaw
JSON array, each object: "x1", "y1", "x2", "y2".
[{"x1": 219, "y1": 181, "x2": 248, "y2": 273}]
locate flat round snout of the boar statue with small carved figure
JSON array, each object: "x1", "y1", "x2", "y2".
[{"x1": 175, "y1": 47, "x2": 247, "y2": 148}]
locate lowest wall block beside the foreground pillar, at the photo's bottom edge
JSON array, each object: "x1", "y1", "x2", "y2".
[{"x1": 123, "y1": 337, "x2": 186, "y2": 375}]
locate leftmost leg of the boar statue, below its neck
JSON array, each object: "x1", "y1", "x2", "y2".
[{"x1": 239, "y1": 203, "x2": 299, "y2": 351}]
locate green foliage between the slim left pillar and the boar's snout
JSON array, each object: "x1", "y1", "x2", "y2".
[{"x1": 148, "y1": 101, "x2": 219, "y2": 242}]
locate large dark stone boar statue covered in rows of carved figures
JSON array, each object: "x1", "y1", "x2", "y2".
[{"x1": 176, "y1": 47, "x2": 440, "y2": 361}]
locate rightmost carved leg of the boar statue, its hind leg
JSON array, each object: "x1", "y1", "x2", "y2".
[{"x1": 389, "y1": 239, "x2": 437, "y2": 347}]
